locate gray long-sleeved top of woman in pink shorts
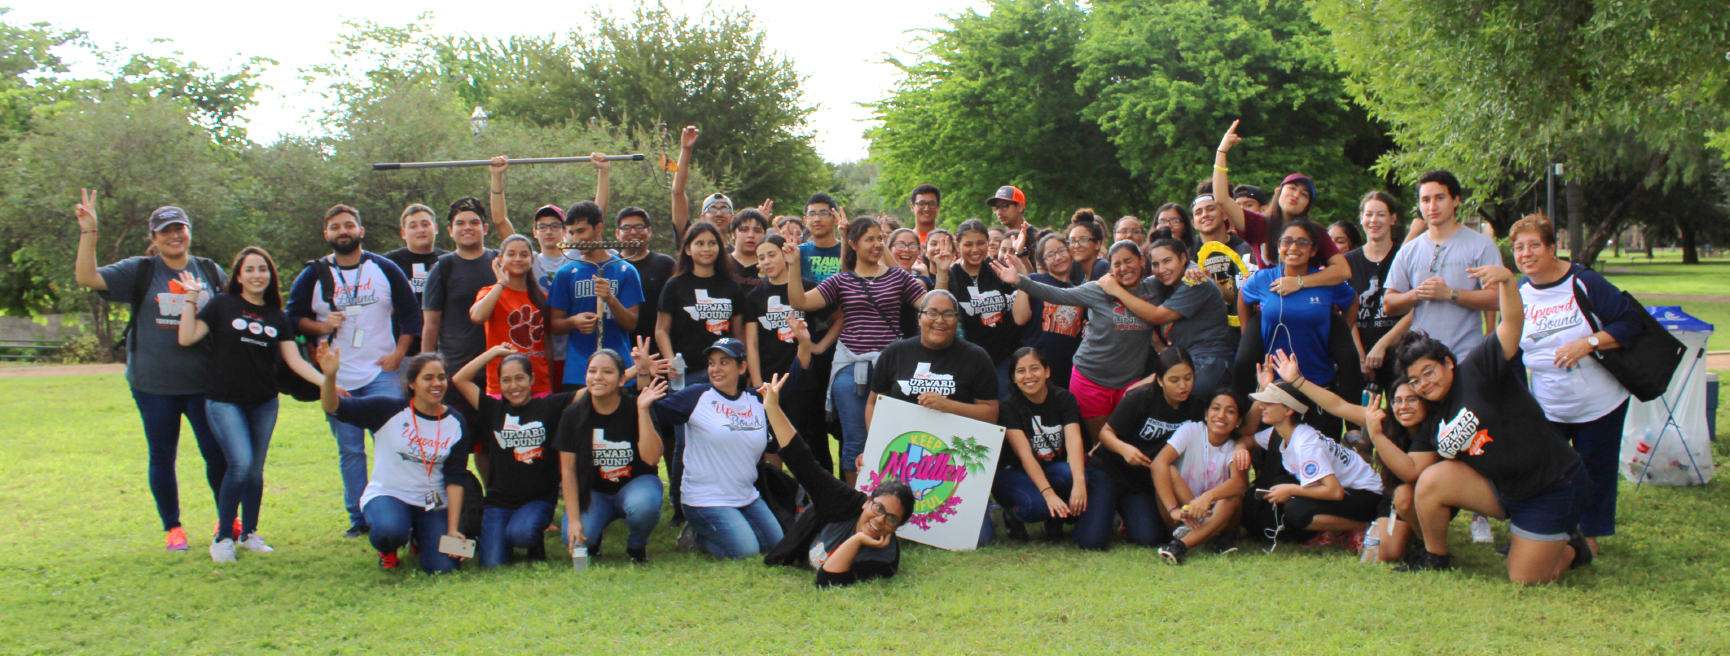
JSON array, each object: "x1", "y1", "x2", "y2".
[{"x1": 1016, "y1": 275, "x2": 1166, "y2": 389}]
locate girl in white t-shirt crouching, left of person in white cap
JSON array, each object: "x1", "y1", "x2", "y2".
[{"x1": 1154, "y1": 388, "x2": 1249, "y2": 564}]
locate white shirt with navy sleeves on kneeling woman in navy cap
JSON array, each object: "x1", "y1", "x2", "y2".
[{"x1": 656, "y1": 383, "x2": 768, "y2": 507}]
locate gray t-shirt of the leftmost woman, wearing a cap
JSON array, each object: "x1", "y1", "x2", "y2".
[{"x1": 97, "y1": 256, "x2": 228, "y2": 395}]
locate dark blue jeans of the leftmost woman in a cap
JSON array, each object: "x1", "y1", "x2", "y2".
[{"x1": 131, "y1": 389, "x2": 232, "y2": 531}]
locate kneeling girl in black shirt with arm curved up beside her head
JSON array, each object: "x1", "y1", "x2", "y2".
[{"x1": 450, "y1": 341, "x2": 576, "y2": 568}]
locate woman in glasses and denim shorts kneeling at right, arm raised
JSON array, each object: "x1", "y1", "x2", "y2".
[{"x1": 1394, "y1": 265, "x2": 1592, "y2": 583}]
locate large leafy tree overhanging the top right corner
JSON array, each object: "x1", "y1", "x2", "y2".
[{"x1": 1315, "y1": 0, "x2": 1730, "y2": 265}]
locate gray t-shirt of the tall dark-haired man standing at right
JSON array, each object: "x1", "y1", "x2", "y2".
[{"x1": 1387, "y1": 227, "x2": 1502, "y2": 358}]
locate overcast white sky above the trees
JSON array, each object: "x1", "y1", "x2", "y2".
[{"x1": 7, "y1": 0, "x2": 983, "y2": 163}]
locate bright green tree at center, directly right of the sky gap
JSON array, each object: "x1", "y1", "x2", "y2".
[{"x1": 870, "y1": 0, "x2": 1159, "y2": 225}]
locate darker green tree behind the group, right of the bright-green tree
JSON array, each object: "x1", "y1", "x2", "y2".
[{"x1": 1076, "y1": 0, "x2": 1386, "y2": 218}]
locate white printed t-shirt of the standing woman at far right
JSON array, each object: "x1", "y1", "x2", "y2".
[{"x1": 1519, "y1": 273, "x2": 1628, "y2": 424}]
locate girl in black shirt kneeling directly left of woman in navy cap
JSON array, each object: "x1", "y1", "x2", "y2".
[{"x1": 554, "y1": 338, "x2": 667, "y2": 564}]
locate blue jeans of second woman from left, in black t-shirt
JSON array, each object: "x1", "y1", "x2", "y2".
[{"x1": 204, "y1": 398, "x2": 279, "y2": 540}]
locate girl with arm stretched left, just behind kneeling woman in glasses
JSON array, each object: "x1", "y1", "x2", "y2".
[{"x1": 1270, "y1": 351, "x2": 1429, "y2": 563}]
